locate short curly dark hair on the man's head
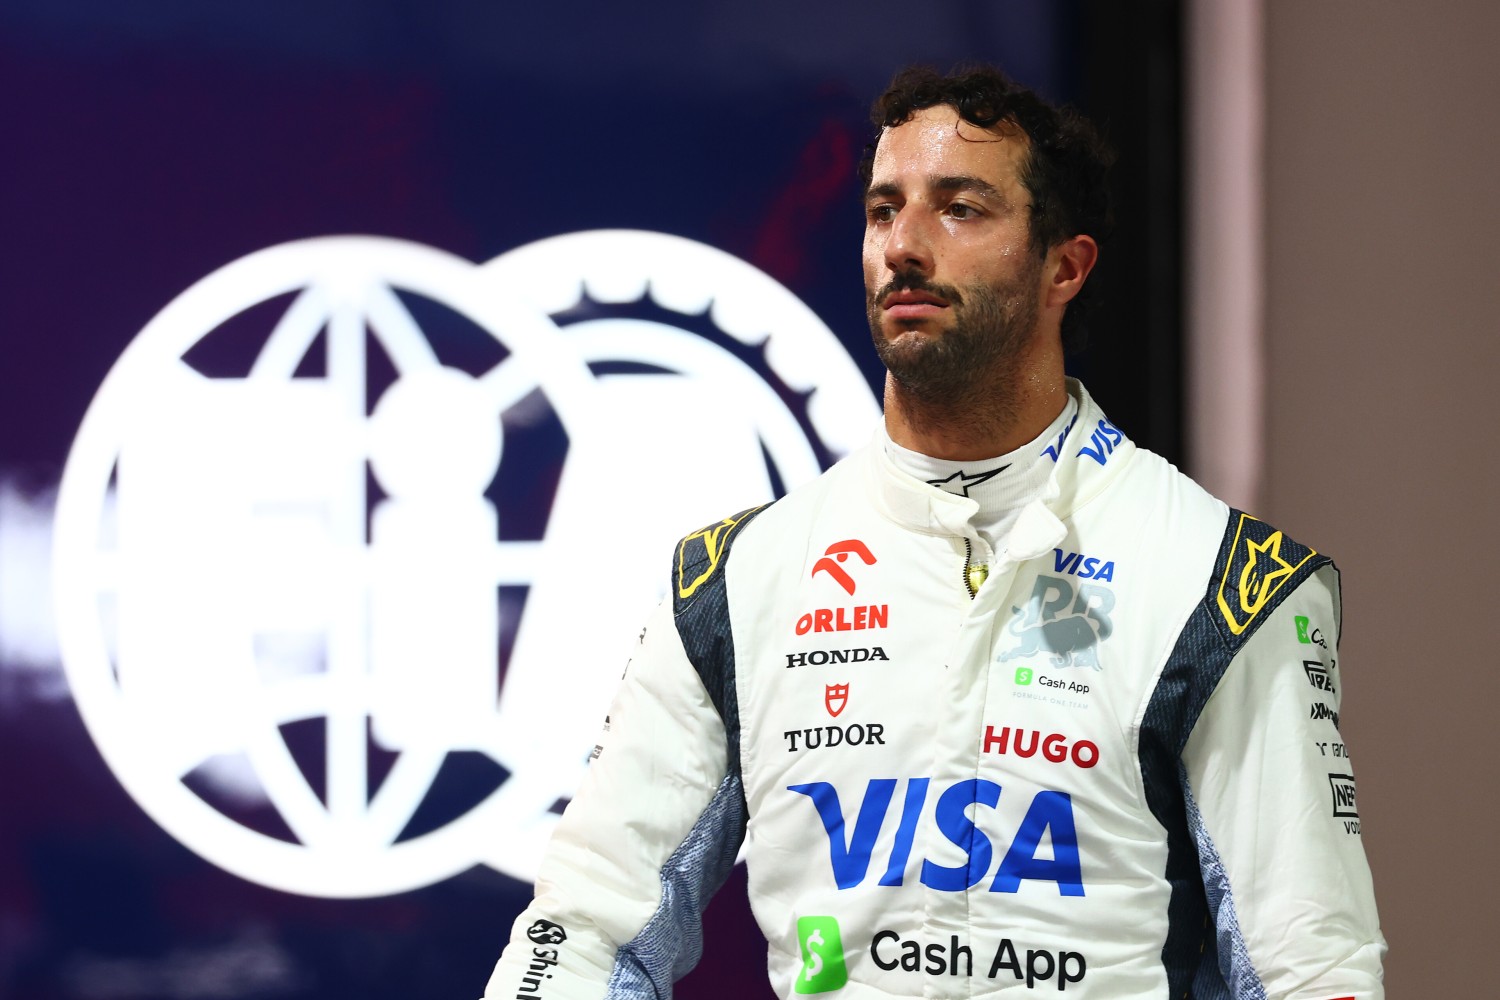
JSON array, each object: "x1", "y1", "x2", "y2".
[{"x1": 860, "y1": 66, "x2": 1115, "y2": 354}]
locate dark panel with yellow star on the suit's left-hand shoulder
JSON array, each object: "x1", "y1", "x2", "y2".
[{"x1": 672, "y1": 504, "x2": 770, "y2": 774}]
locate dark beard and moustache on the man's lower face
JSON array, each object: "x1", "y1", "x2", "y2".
[{"x1": 866, "y1": 260, "x2": 1043, "y2": 421}]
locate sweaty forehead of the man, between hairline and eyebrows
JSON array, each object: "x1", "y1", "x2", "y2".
[{"x1": 870, "y1": 105, "x2": 1028, "y2": 192}]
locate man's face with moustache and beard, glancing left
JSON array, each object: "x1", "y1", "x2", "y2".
[{"x1": 864, "y1": 105, "x2": 1043, "y2": 402}]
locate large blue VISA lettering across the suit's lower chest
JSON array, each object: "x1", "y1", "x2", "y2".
[{"x1": 788, "y1": 778, "x2": 1083, "y2": 897}]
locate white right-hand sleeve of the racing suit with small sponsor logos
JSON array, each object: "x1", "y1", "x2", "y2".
[{"x1": 1182, "y1": 564, "x2": 1386, "y2": 1000}]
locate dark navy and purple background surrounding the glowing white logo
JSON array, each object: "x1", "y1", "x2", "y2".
[{"x1": 0, "y1": 0, "x2": 1178, "y2": 1000}]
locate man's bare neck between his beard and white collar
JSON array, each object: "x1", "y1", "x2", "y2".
[{"x1": 885, "y1": 338, "x2": 1068, "y2": 462}]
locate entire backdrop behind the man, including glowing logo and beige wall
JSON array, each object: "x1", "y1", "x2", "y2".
[{"x1": 0, "y1": 0, "x2": 1500, "y2": 1000}]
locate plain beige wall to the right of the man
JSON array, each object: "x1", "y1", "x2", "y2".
[{"x1": 1262, "y1": 0, "x2": 1500, "y2": 1000}]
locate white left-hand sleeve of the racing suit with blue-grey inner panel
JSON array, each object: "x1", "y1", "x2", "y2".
[{"x1": 485, "y1": 601, "x2": 744, "y2": 1000}]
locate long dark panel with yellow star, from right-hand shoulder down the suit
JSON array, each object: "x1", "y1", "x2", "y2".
[{"x1": 1140, "y1": 508, "x2": 1329, "y2": 997}]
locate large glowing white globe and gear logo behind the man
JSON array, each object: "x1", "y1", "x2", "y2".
[{"x1": 54, "y1": 231, "x2": 878, "y2": 897}]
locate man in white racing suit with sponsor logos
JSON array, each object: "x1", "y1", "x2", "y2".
[{"x1": 488, "y1": 70, "x2": 1385, "y2": 1000}]
